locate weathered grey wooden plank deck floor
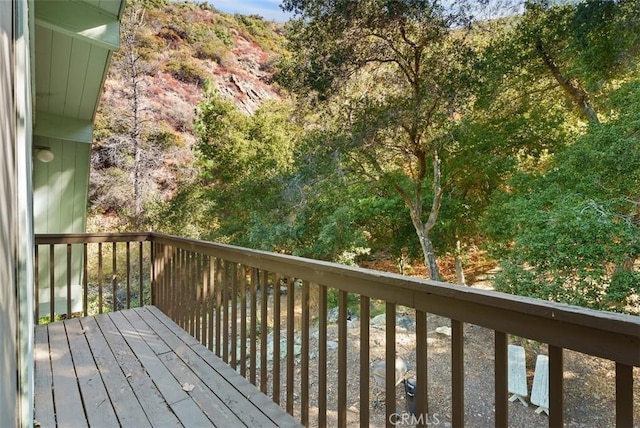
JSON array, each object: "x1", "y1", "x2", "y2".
[{"x1": 34, "y1": 306, "x2": 300, "y2": 428}]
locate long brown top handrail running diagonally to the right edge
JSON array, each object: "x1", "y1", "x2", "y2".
[{"x1": 151, "y1": 233, "x2": 640, "y2": 366}]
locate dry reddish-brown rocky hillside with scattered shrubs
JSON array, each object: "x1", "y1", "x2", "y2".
[{"x1": 88, "y1": 0, "x2": 283, "y2": 230}]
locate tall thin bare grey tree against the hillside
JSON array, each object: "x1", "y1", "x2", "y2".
[{"x1": 89, "y1": 1, "x2": 172, "y2": 230}]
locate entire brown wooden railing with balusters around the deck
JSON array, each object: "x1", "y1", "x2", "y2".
[{"x1": 35, "y1": 233, "x2": 640, "y2": 427}]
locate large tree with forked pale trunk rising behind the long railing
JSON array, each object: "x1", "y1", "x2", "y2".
[{"x1": 277, "y1": 0, "x2": 484, "y2": 280}]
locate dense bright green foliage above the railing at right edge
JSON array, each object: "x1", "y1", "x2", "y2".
[{"x1": 486, "y1": 83, "x2": 640, "y2": 310}]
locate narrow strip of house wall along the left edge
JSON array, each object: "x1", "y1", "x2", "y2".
[{"x1": 0, "y1": 0, "x2": 33, "y2": 427}]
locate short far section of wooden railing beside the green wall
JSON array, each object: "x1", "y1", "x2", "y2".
[{"x1": 34, "y1": 233, "x2": 152, "y2": 322}]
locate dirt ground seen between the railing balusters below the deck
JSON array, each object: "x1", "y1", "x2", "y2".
[{"x1": 266, "y1": 315, "x2": 640, "y2": 428}]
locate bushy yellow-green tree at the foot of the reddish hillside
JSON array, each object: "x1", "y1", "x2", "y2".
[{"x1": 166, "y1": 85, "x2": 298, "y2": 244}]
